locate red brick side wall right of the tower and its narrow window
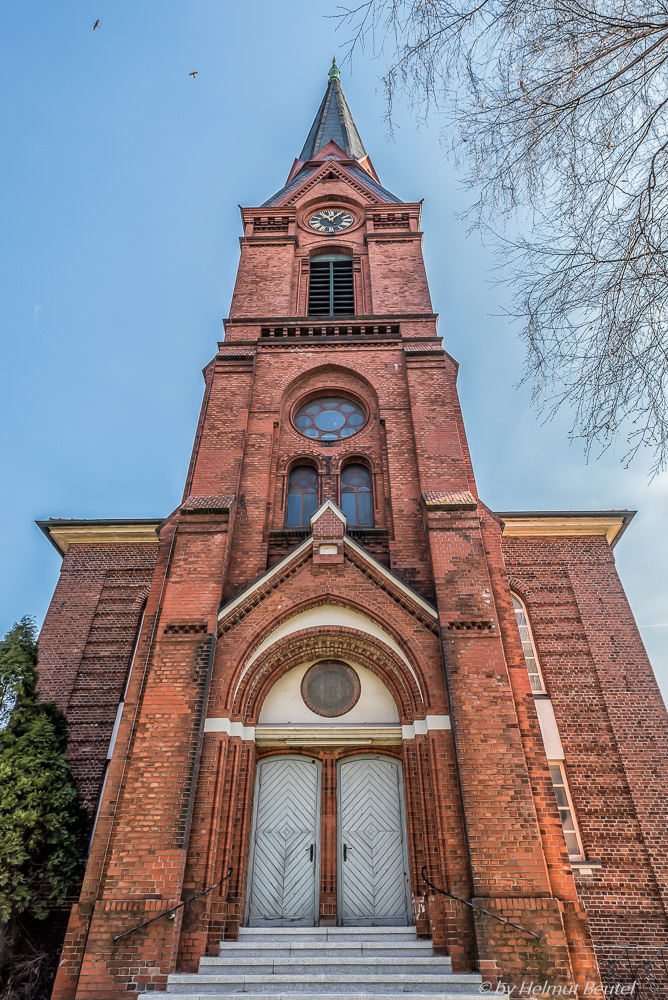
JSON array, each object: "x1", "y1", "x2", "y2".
[{"x1": 503, "y1": 536, "x2": 668, "y2": 968}]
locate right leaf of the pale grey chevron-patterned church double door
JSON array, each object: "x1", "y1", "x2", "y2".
[{"x1": 339, "y1": 757, "x2": 410, "y2": 924}]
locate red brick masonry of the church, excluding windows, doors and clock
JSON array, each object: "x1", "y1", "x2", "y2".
[{"x1": 40, "y1": 88, "x2": 668, "y2": 1000}]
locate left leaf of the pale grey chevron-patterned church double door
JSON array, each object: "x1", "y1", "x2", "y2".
[{"x1": 248, "y1": 757, "x2": 320, "y2": 927}]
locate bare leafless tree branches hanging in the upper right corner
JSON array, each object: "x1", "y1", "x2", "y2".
[{"x1": 340, "y1": 0, "x2": 668, "y2": 471}]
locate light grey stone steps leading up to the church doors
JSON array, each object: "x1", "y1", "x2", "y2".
[{"x1": 140, "y1": 927, "x2": 481, "y2": 1000}]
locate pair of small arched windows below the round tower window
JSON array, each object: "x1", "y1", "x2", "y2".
[{"x1": 285, "y1": 463, "x2": 373, "y2": 528}]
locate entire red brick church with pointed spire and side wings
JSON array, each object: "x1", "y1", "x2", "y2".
[{"x1": 40, "y1": 66, "x2": 668, "y2": 1000}]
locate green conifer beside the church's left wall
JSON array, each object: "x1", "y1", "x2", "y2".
[{"x1": 0, "y1": 618, "x2": 88, "y2": 1000}]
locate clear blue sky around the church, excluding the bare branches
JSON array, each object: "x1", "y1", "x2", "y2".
[{"x1": 0, "y1": 0, "x2": 668, "y2": 696}]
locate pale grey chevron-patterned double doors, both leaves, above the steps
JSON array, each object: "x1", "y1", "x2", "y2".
[{"x1": 248, "y1": 755, "x2": 410, "y2": 927}]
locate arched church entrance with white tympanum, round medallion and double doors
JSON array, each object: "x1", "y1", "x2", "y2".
[{"x1": 236, "y1": 620, "x2": 426, "y2": 926}]
